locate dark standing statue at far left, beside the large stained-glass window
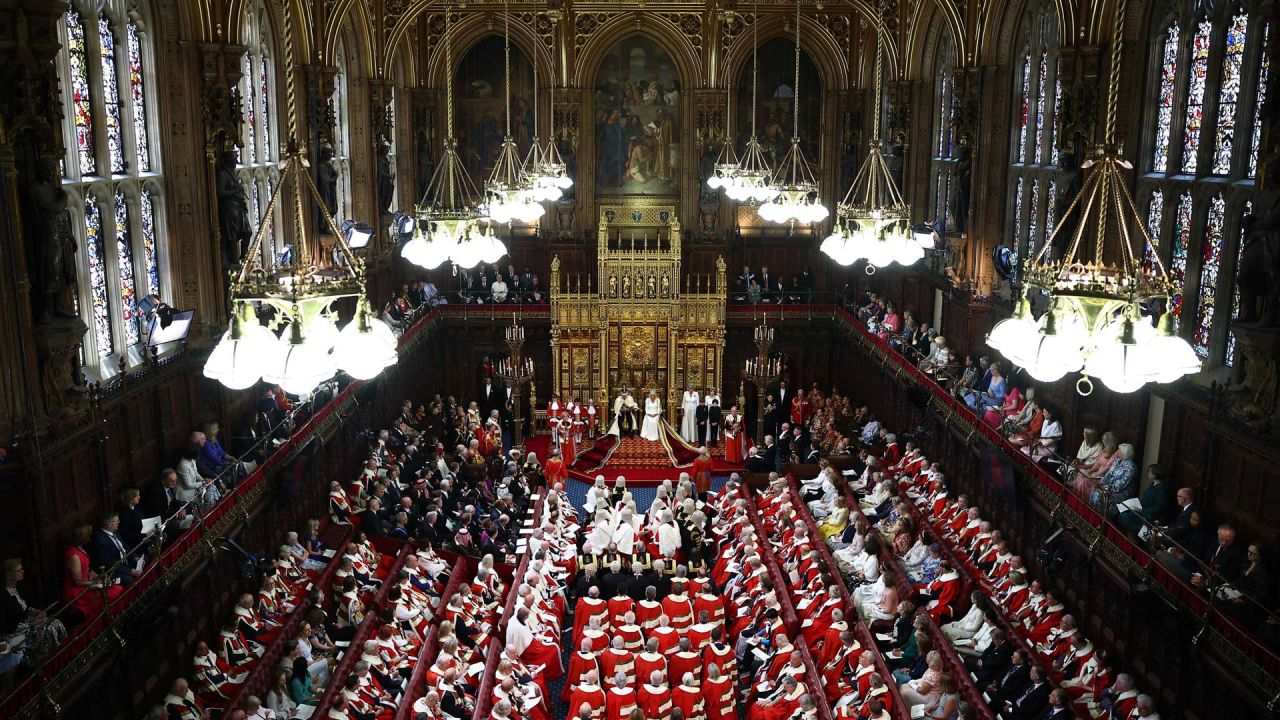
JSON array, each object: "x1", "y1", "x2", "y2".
[{"x1": 26, "y1": 159, "x2": 76, "y2": 323}]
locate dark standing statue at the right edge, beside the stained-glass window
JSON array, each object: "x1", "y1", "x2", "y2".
[{"x1": 1236, "y1": 159, "x2": 1280, "y2": 328}]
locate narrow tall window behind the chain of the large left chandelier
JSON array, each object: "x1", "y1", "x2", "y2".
[{"x1": 237, "y1": 0, "x2": 285, "y2": 266}]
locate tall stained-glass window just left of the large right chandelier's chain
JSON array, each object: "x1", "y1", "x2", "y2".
[{"x1": 1009, "y1": 3, "x2": 1062, "y2": 274}]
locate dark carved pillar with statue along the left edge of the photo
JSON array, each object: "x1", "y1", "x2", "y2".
[{"x1": 0, "y1": 3, "x2": 87, "y2": 443}]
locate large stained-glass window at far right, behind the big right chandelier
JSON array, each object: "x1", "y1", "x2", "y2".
[{"x1": 1138, "y1": 0, "x2": 1270, "y2": 366}]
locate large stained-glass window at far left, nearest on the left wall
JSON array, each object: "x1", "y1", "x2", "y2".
[{"x1": 58, "y1": 0, "x2": 169, "y2": 368}]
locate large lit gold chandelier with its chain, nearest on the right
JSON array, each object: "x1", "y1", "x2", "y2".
[{"x1": 987, "y1": 0, "x2": 1201, "y2": 395}]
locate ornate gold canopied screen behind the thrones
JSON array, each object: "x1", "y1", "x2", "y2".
[{"x1": 550, "y1": 200, "x2": 726, "y2": 419}]
